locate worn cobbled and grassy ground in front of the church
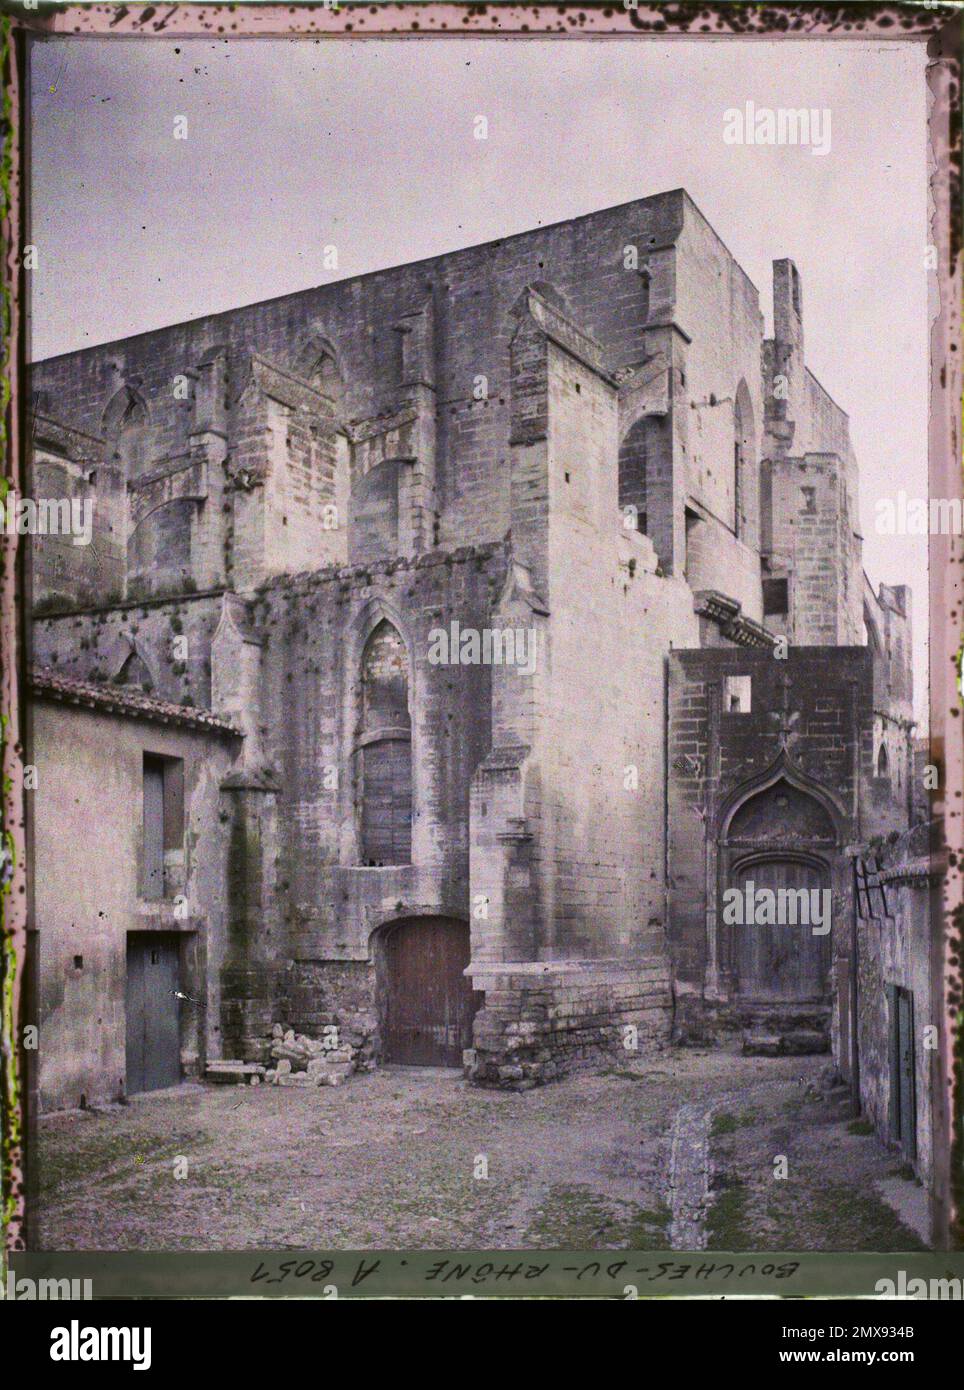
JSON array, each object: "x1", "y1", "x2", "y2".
[{"x1": 35, "y1": 1049, "x2": 920, "y2": 1250}]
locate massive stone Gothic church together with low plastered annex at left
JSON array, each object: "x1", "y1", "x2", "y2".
[{"x1": 31, "y1": 190, "x2": 914, "y2": 1105}]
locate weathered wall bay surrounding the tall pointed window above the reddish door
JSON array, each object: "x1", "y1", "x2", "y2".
[{"x1": 251, "y1": 546, "x2": 506, "y2": 960}]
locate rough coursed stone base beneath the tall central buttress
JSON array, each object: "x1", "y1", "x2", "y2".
[{"x1": 465, "y1": 959, "x2": 672, "y2": 1091}]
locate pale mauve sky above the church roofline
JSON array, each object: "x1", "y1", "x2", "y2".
[{"x1": 29, "y1": 38, "x2": 928, "y2": 712}]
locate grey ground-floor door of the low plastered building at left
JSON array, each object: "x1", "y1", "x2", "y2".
[{"x1": 126, "y1": 931, "x2": 181, "y2": 1095}]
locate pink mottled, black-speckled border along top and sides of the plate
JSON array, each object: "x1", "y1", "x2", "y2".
[{"x1": 0, "y1": 0, "x2": 964, "y2": 1276}]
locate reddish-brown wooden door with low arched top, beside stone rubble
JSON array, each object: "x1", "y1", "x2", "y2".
[{"x1": 375, "y1": 917, "x2": 482, "y2": 1066}]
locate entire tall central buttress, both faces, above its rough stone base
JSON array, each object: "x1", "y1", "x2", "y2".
[{"x1": 471, "y1": 296, "x2": 697, "y2": 987}]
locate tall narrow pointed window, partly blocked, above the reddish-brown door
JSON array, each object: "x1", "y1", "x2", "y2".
[{"x1": 356, "y1": 619, "x2": 411, "y2": 867}]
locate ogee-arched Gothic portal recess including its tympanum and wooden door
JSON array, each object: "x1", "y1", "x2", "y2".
[{"x1": 717, "y1": 753, "x2": 843, "y2": 1006}]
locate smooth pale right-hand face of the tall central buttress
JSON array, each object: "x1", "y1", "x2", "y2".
[{"x1": 544, "y1": 345, "x2": 697, "y2": 959}]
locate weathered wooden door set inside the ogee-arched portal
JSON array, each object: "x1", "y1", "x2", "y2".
[{"x1": 729, "y1": 859, "x2": 831, "y2": 1001}]
